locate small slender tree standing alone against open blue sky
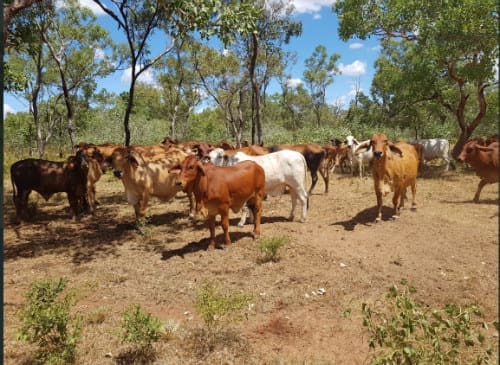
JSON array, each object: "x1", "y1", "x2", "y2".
[{"x1": 304, "y1": 45, "x2": 340, "y2": 127}]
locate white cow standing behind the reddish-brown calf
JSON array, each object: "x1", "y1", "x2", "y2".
[{"x1": 208, "y1": 148, "x2": 308, "y2": 227}]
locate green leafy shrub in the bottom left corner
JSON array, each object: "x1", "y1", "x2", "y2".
[{"x1": 19, "y1": 278, "x2": 81, "y2": 364}]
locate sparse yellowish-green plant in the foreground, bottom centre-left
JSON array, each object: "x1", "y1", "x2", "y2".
[{"x1": 194, "y1": 282, "x2": 252, "y2": 332}]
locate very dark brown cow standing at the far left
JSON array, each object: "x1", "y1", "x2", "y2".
[{"x1": 10, "y1": 151, "x2": 88, "y2": 223}]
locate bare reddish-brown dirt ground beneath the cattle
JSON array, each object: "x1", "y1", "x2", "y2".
[{"x1": 3, "y1": 166, "x2": 499, "y2": 364}]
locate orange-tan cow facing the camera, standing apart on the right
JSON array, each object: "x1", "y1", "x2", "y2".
[{"x1": 359, "y1": 133, "x2": 418, "y2": 222}]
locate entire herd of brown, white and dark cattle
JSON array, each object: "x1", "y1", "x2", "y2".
[{"x1": 10, "y1": 134, "x2": 499, "y2": 248}]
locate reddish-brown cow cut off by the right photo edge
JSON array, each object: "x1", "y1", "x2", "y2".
[{"x1": 457, "y1": 140, "x2": 498, "y2": 203}]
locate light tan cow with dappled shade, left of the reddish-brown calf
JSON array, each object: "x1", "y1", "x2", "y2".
[{"x1": 112, "y1": 146, "x2": 194, "y2": 220}]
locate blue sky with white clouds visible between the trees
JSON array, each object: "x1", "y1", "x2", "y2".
[{"x1": 3, "y1": 0, "x2": 380, "y2": 116}]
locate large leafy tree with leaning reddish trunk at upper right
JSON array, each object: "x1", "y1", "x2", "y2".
[{"x1": 333, "y1": 0, "x2": 499, "y2": 157}]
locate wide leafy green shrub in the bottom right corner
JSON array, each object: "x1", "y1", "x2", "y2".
[{"x1": 362, "y1": 280, "x2": 494, "y2": 365}]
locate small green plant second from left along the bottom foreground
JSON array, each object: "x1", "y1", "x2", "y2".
[{"x1": 119, "y1": 305, "x2": 162, "y2": 350}]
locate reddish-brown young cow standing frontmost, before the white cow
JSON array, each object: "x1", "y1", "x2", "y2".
[{"x1": 170, "y1": 156, "x2": 265, "y2": 249}]
